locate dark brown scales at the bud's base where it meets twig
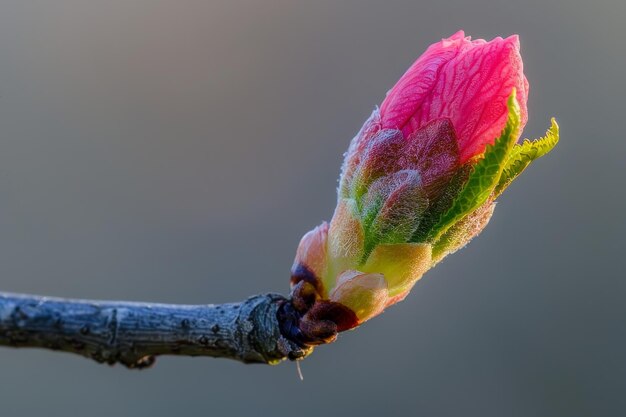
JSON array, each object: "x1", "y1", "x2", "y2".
[{"x1": 277, "y1": 265, "x2": 358, "y2": 347}]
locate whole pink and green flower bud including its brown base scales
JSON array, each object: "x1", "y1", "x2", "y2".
[{"x1": 291, "y1": 32, "x2": 558, "y2": 344}]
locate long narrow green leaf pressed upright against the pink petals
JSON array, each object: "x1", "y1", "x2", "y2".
[{"x1": 426, "y1": 90, "x2": 520, "y2": 242}]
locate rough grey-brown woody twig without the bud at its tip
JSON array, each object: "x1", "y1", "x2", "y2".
[{"x1": 0, "y1": 292, "x2": 312, "y2": 368}]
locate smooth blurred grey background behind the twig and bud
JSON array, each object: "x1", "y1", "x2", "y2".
[{"x1": 0, "y1": 0, "x2": 626, "y2": 417}]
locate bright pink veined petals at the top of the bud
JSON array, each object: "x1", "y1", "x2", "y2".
[{"x1": 381, "y1": 32, "x2": 528, "y2": 163}]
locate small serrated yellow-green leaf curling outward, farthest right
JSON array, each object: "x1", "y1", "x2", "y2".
[{"x1": 494, "y1": 118, "x2": 559, "y2": 197}]
